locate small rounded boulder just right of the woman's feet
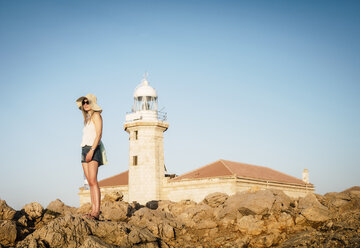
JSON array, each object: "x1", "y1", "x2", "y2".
[{"x1": 101, "y1": 201, "x2": 129, "y2": 221}]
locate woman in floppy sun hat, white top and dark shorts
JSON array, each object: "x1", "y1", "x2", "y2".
[{"x1": 76, "y1": 94, "x2": 104, "y2": 220}]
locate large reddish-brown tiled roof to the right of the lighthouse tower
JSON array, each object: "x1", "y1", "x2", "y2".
[{"x1": 170, "y1": 159, "x2": 306, "y2": 185}]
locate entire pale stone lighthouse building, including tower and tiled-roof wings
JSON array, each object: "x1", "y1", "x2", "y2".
[{"x1": 79, "y1": 79, "x2": 314, "y2": 205}]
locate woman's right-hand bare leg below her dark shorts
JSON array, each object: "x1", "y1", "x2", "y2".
[{"x1": 87, "y1": 160, "x2": 101, "y2": 216}]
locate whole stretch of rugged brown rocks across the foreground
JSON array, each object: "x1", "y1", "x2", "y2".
[{"x1": 0, "y1": 188, "x2": 360, "y2": 248}]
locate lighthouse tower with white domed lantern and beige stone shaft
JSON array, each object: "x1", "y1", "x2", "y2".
[{"x1": 124, "y1": 77, "x2": 169, "y2": 204}]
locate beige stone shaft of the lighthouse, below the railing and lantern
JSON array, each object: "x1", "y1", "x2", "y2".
[{"x1": 124, "y1": 121, "x2": 169, "y2": 204}]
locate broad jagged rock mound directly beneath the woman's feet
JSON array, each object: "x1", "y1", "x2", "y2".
[{"x1": 17, "y1": 214, "x2": 156, "y2": 248}]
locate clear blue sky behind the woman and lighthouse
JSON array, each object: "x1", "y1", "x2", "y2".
[{"x1": 0, "y1": 0, "x2": 360, "y2": 209}]
